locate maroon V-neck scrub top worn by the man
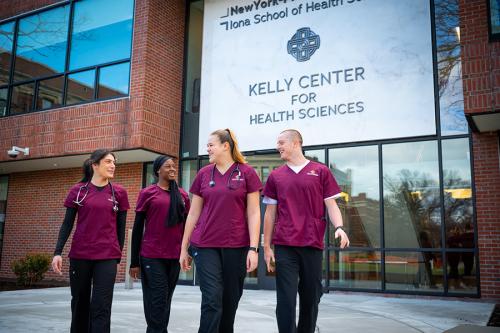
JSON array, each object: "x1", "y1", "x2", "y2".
[{"x1": 263, "y1": 161, "x2": 341, "y2": 249}]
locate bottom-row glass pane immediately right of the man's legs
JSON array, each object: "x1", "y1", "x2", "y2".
[{"x1": 329, "y1": 251, "x2": 382, "y2": 289}]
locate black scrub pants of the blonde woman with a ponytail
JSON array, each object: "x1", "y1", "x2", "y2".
[{"x1": 190, "y1": 246, "x2": 248, "y2": 333}]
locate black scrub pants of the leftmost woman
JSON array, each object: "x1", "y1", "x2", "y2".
[{"x1": 69, "y1": 259, "x2": 118, "y2": 333}]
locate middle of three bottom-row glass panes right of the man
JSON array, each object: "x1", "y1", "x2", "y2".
[{"x1": 385, "y1": 252, "x2": 443, "y2": 292}]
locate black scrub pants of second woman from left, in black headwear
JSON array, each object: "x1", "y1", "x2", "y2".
[{"x1": 141, "y1": 257, "x2": 180, "y2": 333}]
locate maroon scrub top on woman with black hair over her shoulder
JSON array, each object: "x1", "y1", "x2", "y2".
[{"x1": 135, "y1": 184, "x2": 189, "y2": 259}]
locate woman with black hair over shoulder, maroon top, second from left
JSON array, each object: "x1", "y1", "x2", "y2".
[{"x1": 130, "y1": 155, "x2": 189, "y2": 333}]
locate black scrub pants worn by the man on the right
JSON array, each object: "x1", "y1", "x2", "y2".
[{"x1": 275, "y1": 245, "x2": 323, "y2": 333}]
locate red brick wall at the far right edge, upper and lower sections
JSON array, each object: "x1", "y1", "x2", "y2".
[{"x1": 460, "y1": 0, "x2": 500, "y2": 299}]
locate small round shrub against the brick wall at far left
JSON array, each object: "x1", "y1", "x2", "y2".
[{"x1": 12, "y1": 253, "x2": 52, "y2": 287}]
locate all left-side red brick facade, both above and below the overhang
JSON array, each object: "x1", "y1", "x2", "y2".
[{"x1": 0, "y1": 0, "x2": 185, "y2": 281}]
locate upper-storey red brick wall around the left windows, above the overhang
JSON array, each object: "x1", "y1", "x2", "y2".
[{"x1": 0, "y1": 0, "x2": 185, "y2": 162}]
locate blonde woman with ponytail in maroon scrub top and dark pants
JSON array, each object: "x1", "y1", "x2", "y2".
[{"x1": 180, "y1": 129, "x2": 262, "y2": 333}]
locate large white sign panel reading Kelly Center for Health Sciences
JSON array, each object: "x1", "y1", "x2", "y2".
[{"x1": 199, "y1": 0, "x2": 436, "y2": 154}]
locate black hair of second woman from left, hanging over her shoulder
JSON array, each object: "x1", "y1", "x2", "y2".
[{"x1": 153, "y1": 155, "x2": 186, "y2": 227}]
